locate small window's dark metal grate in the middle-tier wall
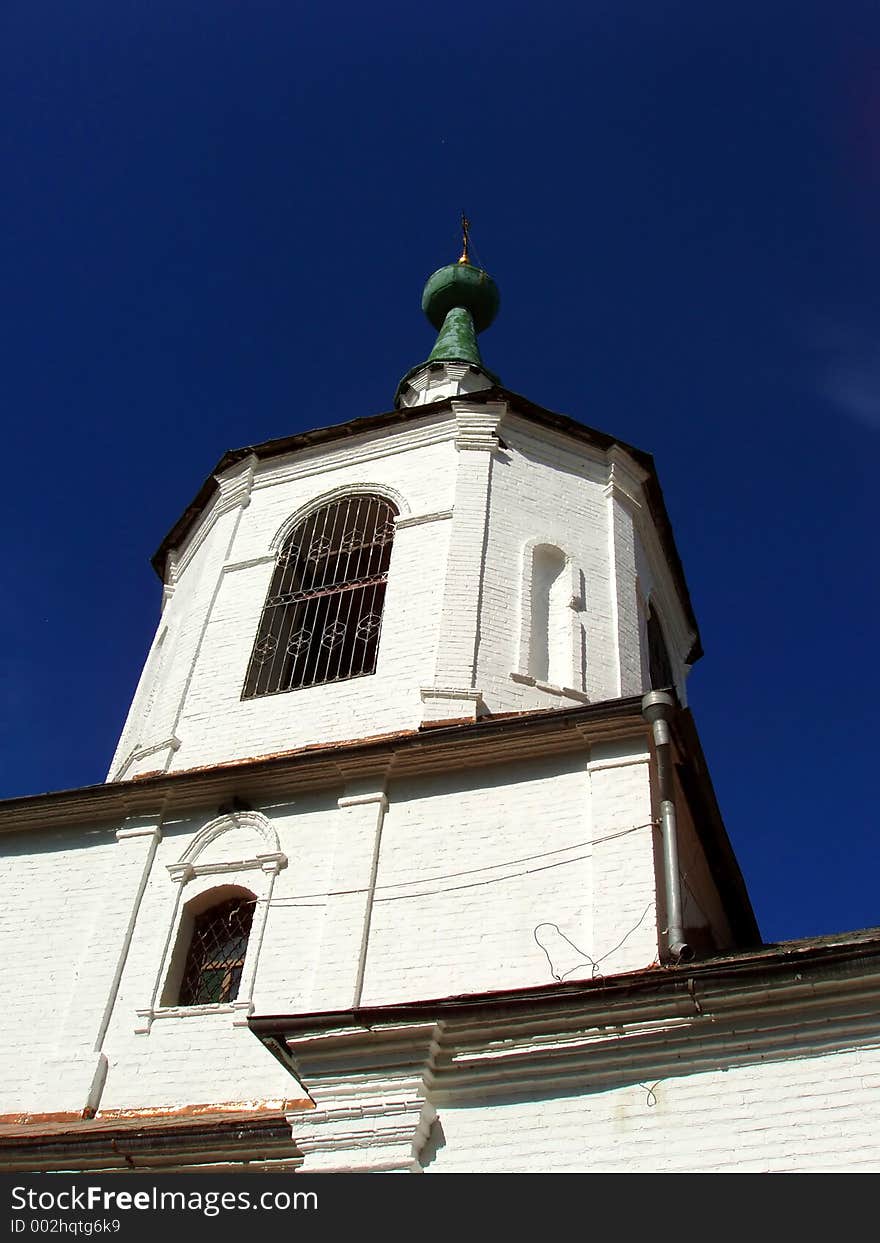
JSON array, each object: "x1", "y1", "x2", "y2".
[{"x1": 179, "y1": 897, "x2": 254, "y2": 1006}]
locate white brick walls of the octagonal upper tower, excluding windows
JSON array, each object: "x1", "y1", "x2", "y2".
[{"x1": 111, "y1": 401, "x2": 689, "y2": 779}]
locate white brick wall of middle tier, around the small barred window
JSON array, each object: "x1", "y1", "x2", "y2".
[{"x1": 0, "y1": 740, "x2": 691, "y2": 1114}]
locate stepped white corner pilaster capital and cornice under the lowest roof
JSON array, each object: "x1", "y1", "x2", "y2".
[{"x1": 251, "y1": 947, "x2": 880, "y2": 1128}]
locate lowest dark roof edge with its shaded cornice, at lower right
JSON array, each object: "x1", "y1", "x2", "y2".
[{"x1": 249, "y1": 929, "x2": 880, "y2": 1103}]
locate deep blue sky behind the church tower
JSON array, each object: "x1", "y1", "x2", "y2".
[{"x1": 0, "y1": 0, "x2": 880, "y2": 940}]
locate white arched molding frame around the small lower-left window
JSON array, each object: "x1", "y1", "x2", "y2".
[{"x1": 134, "y1": 812, "x2": 287, "y2": 1035}]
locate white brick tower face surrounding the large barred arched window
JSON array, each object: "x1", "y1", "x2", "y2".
[{"x1": 109, "y1": 420, "x2": 456, "y2": 779}]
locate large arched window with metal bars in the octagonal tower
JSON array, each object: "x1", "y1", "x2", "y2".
[{"x1": 241, "y1": 493, "x2": 398, "y2": 699}]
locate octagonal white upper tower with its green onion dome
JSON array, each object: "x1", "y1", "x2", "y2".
[{"x1": 108, "y1": 244, "x2": 700, "y2": 782}]
